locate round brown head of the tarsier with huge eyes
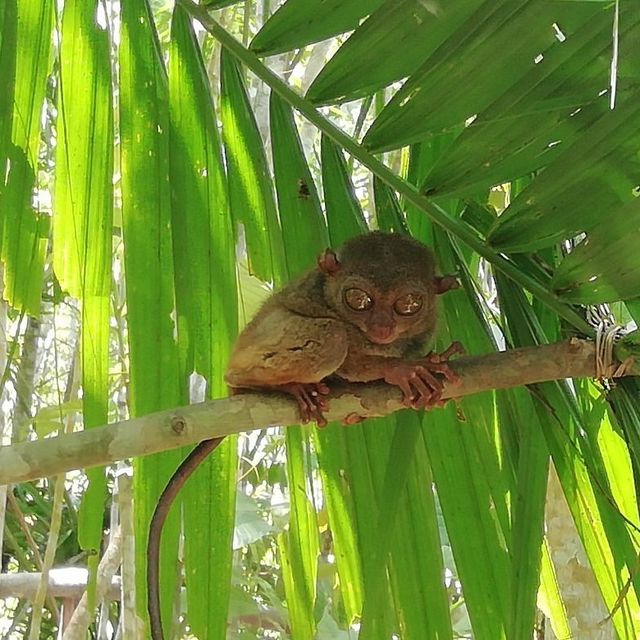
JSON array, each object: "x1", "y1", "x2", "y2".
[{"x1": 318, "y1": 231, "x2": 458, "y2": 344}]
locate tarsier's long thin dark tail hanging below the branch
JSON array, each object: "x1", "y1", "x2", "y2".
[{"x1": 147, "y1": 438, "x2": 224, "y2": 640}]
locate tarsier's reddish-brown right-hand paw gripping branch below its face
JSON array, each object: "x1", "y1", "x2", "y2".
[{"x1": 384, "y1": 342, "x2": 464, "y2": 409}]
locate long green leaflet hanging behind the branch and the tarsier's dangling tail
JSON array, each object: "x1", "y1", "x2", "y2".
[{"x1": 119, "y1": 0, "x2": 180, "y2": 630}]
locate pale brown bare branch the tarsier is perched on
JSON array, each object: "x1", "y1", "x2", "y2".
[{"x1": 0, "y1": 338, "x2": 632, "y2": 485}]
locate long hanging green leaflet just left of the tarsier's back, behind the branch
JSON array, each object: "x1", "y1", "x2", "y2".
[{"x1": 169, "y1": 6, "x2": 237, "y2": 640}]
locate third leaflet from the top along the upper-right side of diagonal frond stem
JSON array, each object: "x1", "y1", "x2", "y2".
[{"x1": 364, "y1": 0, "x2": 611, "y2": 151}]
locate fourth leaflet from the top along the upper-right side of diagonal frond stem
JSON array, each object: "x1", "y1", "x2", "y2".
[{"x1": 421, "y1": 5, "x2": 640, "y2": 199}]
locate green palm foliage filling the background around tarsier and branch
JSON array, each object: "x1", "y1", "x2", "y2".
[{"x1": 0, "y1": 0, "x2": 640, "y2": 640}]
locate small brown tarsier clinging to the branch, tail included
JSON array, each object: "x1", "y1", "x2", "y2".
[{"x1": 148, "y1": 232, "x2": 462, "y2": 640}]
